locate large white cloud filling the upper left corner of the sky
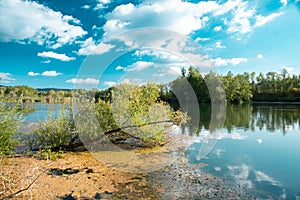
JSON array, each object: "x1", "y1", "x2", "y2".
[{"x1": 0, "y1": 0, "x2": 87, "y2": 48}]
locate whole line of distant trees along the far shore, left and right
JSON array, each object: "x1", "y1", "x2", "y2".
[{"x1": 0, "y1": 67, "x2": 300, "y2": 104}]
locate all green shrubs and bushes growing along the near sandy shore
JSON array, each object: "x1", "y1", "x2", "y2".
[{"x1": 0, "y1": 83, "x2": 189, "y2": 158}]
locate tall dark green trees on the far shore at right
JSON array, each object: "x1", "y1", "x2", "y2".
[{"x1": 161, "y1": 67, "x2": 300, "y2": 107}]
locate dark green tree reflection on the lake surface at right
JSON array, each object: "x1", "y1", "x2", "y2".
[{"x1": 188, "y1": 104, "x2": 300, "y2": 134}]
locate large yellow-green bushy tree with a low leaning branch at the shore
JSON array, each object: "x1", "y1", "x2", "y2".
[{"x1": 77, "y1": 83, "x2": 188, "y2": 146}]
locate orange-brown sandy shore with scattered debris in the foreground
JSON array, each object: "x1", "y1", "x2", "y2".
[{"x1": 0, "y1": 152, "x2": 254, "y2": 200}]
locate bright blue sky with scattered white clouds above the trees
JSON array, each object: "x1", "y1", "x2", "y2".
[{"x1": 0, "y1": 0, "x2": 300, "y2": 88}]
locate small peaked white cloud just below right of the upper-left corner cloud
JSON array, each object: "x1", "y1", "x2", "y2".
[{"x1": 77, "y1": 37, "x2": 115, "y2": 55}]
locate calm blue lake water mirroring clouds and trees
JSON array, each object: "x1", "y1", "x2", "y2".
[{"x1": 25, "y1": 103, "x2": 300, "y2": 199}]
